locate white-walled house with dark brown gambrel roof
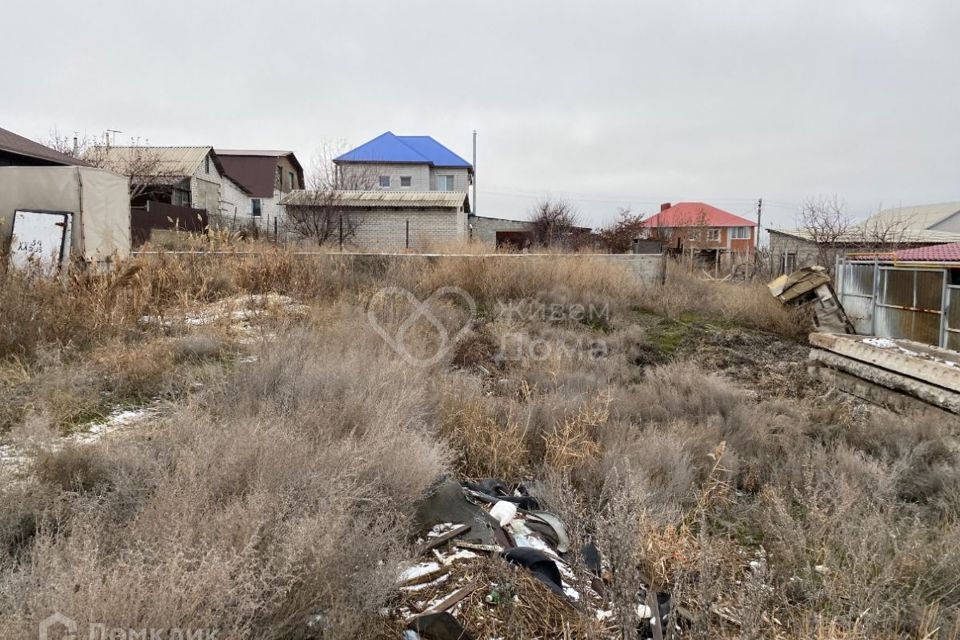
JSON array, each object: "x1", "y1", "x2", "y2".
[{"x1": 216, "y1": 149, "x2": 304, "y2": 233}]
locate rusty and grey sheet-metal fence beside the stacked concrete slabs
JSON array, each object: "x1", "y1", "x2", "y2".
[{"x1": 837, "y1": 260, "x2": 960, "y2": 350}]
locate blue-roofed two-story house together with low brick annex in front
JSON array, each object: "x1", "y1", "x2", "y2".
[{"x1": 282, "y1": 131, "x2": 473, "y2": 251}]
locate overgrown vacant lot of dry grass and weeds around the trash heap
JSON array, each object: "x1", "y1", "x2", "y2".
[{"x1": 0, "y1": 249, "x2": 960, "y2": 638}]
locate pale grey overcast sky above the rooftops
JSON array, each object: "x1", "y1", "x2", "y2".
[{"x1": 0, "y1": 0, "x2": 960, "y2": 235}]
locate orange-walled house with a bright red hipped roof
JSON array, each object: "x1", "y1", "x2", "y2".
[{"x1": 643, "y1": 202, "x2": 757, "y2": 259}]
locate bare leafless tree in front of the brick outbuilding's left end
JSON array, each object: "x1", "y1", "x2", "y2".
[{"x1": 284, "y1": 145, "x2": 376, "y2": 246}]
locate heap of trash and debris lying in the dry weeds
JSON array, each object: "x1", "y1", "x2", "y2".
[{"x1": 391, "y1": 478, "x2": 674, "y2": 640}]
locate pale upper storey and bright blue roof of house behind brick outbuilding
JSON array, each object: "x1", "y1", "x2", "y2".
[{"x1": 333, "y1": 131, "x2": 473, "y2": 194}]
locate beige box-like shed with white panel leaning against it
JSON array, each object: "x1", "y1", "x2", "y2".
[{"x1": 0, "y1": 166, "x2": 130, "y2": 262}]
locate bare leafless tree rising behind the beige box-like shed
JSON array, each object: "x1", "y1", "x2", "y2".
[{"x1": 44, "y1": 128, "x2": 186, "y2": 202}]
